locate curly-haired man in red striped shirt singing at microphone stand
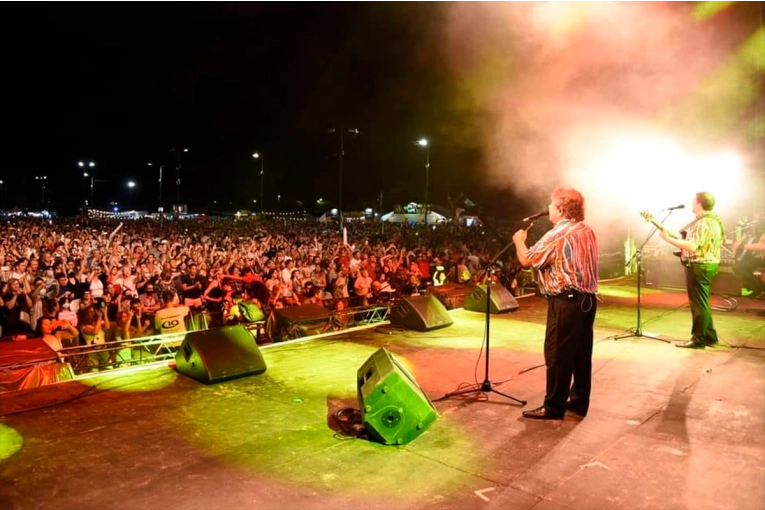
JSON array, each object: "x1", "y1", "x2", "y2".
[{"x1": 513, "y1": 188, "x2": 598, "y2": 420}]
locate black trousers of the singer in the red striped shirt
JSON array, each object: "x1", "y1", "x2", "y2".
[{"x1": 544, "y1": 292, "x2": 597, "y2": 414}]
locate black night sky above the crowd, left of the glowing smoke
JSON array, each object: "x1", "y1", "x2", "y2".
[{"x1": 1, "y1": 0, "x2": 492, "y2": 215}]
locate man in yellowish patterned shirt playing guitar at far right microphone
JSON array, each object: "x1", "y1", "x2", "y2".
[{"x1": 660, "y1": 192, "x2": 725, "y2": 349}]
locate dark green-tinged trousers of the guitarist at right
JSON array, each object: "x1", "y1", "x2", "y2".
[{"x1": 685, "y1": 263, "x2": 718, "y2": 345}]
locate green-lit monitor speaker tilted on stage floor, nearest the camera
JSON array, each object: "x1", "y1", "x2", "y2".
[{"x1": 357, "y1": 349, "x2": 438, "y2": 445}]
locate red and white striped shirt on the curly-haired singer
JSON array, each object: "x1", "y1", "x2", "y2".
[{"x1": 526, "y1": 219, "x2": 598, "y2": 296}]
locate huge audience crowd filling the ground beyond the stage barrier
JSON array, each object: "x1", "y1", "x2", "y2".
[{"x1": 0, "y1": 213, "x2": 516, "y2": 349}]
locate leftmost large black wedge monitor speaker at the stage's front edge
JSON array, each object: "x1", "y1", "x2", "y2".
[{"x1": 175, "y1": 326, "x2": 266, "y2": 384}]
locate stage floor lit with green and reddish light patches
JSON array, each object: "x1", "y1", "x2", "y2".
[{"x1": 0, "y1": 279, "x2": 765, "y2": 510}]
